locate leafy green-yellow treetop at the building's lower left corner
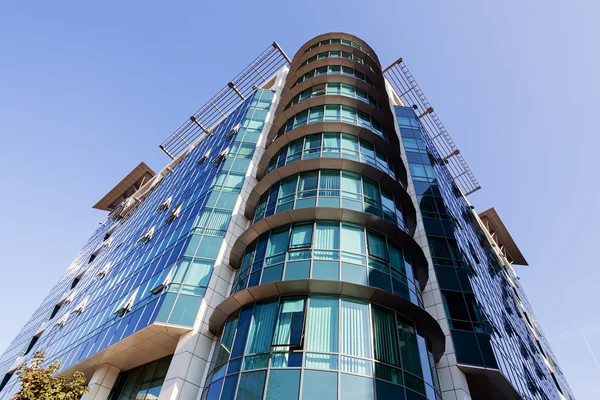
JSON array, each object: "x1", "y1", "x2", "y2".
[{"x1": 13, "y1": 351, "x2": 90, "y2": 400}]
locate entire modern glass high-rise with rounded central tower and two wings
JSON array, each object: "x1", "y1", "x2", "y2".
[{"x1": 0, "y1": 33, "x2": 574, "y2": 400}]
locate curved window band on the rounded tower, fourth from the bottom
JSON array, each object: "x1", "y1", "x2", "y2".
[{"x1": 266, "y1": 132, "x2": 398, "y2": 179}]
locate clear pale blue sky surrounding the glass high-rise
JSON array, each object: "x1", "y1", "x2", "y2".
[{"x1": 0, "y1": 0, "x2": 600, "y2": 400}]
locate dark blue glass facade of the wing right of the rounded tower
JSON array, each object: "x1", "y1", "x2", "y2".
[{"x1": 395, "y1": 107, "x2": 561, "y2": 400}]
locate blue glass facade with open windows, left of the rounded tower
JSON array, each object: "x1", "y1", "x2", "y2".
[{"x1": 0, "y1": 90, "x2": 274, "y2": 400}]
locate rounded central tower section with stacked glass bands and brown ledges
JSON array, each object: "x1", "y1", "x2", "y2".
[{"x1": 203, "y1": 33, "x2": 445, "y2": 400}]
